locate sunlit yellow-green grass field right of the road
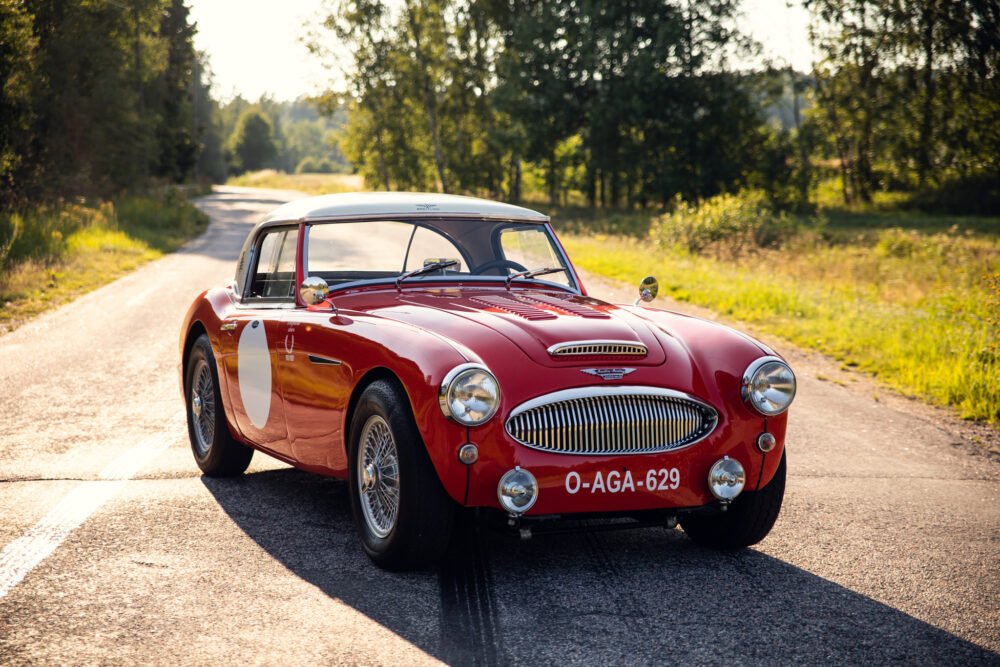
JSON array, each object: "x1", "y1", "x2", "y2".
[{"x1": 563, "y1": 196, "x2": 1000, "y2": 423}]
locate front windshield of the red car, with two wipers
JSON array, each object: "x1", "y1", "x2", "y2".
[{"x1": 305, "y1": 219, "x2": 576, "y2": 289}]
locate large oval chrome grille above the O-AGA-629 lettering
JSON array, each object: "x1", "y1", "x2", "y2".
[{"x1": 506, "y1": 387, "x2": 719, "y2": 455}]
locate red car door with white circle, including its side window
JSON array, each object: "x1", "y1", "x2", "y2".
[{"x1": 221, "y1": 227, "x2": 298, "y2": 457}]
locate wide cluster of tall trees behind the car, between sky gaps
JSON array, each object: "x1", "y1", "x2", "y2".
[{"x1": 320, "y1": 0, "x2": 780, "y2": 205}]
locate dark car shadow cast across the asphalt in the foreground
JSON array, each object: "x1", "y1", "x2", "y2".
[{"x1": 202, "y1": 469, "x2": 1000, "y2": 665}]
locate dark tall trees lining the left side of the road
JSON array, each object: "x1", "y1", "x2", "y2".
[{"x1": 0, "y1": 0, "x2": 217, "y2": 208}]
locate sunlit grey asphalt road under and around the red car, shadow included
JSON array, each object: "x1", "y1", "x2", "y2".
[{"x1": 0, "y1": 189, "x2": 1000, "y2": 665}]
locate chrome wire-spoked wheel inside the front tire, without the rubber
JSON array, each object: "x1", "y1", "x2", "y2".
[{"x1": 356, "y1": 415, "x2": 399, "y2": 538}]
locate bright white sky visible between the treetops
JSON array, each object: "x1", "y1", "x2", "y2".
[{"x1": 188, "y1": 0, "x2": 811, "y2": 100}]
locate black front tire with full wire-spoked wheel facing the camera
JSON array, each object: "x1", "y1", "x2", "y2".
[{"x1": 347, "y1": 380, "x2": 455, "y2": 571}]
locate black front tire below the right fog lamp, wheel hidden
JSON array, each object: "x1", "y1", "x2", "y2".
[{"x1": 680, "y1": 452, "x2": 785, "y2": 551}]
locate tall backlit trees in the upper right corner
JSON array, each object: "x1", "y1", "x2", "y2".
[{"x1": 806, "y1": 0, "x2": 1000, "y2": 205}]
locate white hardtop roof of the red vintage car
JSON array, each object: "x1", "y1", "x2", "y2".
[{"x1": 261, "y1": 192, "x2": 549, "y2": 225}]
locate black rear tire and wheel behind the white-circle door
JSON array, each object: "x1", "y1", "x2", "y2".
[{"x1": 184, "y1": 334, "x2": 253, "y2": 477}]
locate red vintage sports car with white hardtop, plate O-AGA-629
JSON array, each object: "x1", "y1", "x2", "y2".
[{"x1": 180, "y1": 193, "x2": 795, "y2": 569}]
